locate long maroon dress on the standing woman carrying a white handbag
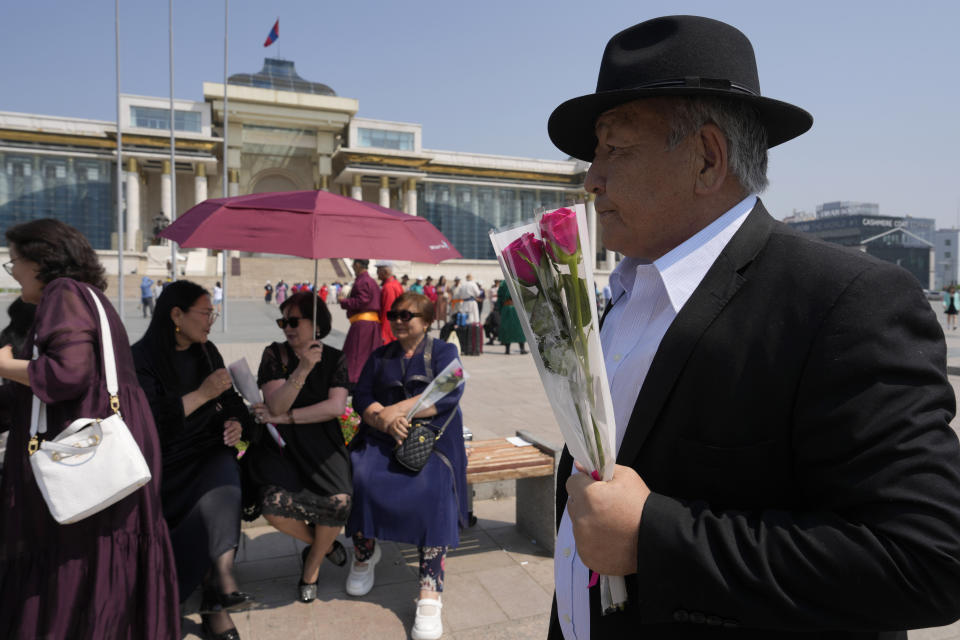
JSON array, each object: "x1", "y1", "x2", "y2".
[{"x1": 0, "y1": 278, "x2": 180, "y2": 640}]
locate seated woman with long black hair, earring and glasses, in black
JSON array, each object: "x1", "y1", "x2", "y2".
[{"x1": 133, "y1": 280, "x2": 257, "y2": 640}]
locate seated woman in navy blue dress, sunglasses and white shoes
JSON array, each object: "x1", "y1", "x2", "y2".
[{"x1": 346, "y1": 291, "x2": 467, "y2": 640}]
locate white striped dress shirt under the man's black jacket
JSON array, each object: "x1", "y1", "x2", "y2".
[{"x1": 553, "y1": 195, "x2": 757, "y2": 640}]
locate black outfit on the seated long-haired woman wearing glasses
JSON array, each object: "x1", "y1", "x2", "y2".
[{"x1": 133, "y1": 341, "x2": 257, "y2": 600}]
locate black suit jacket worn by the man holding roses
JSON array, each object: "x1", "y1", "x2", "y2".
[{"x1": 550, "y1": 202, "x2": 960, "y2": 639}]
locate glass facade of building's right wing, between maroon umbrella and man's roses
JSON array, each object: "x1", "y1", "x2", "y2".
[{"x1": 417, "y1": 182, "x2": 572, "y2": 260}]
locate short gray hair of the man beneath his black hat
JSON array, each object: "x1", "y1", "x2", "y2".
[{"x1": 667, "y1": 96, "x2": 768, "y2": 193}]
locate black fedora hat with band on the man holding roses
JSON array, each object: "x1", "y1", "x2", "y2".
[{"x1": 547, "y1": 16, "x2": 813, "y2": 161}]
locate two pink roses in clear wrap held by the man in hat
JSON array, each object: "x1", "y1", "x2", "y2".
[{"x1": 490, "y1": 205, "x2": 627, "y2": 612}]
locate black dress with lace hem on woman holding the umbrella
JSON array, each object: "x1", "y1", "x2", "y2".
[{"x1": 243, "y1": 342, "x2": 353, "y2": 526}]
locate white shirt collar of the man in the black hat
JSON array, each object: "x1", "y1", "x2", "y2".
[{"x1": 610, "y1": 194, "x2": 757, "y2": 312}]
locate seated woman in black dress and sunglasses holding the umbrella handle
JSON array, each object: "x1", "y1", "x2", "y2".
[{"x1": 244, "y1": 292, "x2": 353, "y2": 602}]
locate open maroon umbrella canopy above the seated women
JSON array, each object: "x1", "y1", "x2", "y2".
[{"x1": 160, "y1": 191, "x2": 461, "y2": 264}]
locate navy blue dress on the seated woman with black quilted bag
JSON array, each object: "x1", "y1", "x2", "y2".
[{"x1": 346, "y1": 340, "x2": 467, "y2": 547}]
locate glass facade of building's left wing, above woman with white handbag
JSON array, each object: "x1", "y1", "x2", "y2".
[{"x1": 0, "y1": 153, "x2": 117, "y2": 249}]
